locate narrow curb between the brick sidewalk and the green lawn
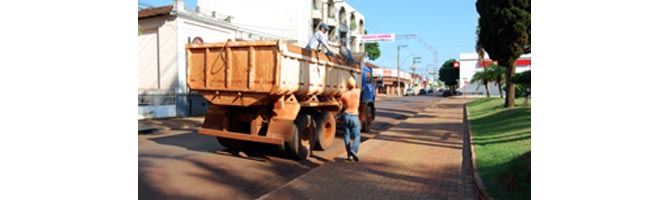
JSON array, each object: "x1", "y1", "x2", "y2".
[{"x1": 463, "y1": 104, "x2": 493, "y2": 200}]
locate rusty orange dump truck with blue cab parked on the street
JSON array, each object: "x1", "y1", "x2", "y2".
[{"x1": 186, "y1": 40, "x2": 375, "y2": 159}]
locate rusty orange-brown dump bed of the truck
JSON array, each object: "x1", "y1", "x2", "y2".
[{"x1": 186, "y1": 41, "x2": 362, "y2": 106}]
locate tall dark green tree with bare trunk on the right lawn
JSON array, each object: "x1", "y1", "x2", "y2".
[{"x1": 476, "y1": 0, "x2": 532, "y2": 108}]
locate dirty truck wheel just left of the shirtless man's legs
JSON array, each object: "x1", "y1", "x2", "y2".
[{"x1": 314, "y1": 111, "x2": 337, "y2": 150}]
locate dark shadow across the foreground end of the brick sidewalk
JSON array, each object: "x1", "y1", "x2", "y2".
[{"x1": 269, "y1": 157, "x2": 461, "y2": 199}]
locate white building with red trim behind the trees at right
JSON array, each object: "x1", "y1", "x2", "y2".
[{"x1": 459, "y1": 53, "x2": 532, "y2": 95}]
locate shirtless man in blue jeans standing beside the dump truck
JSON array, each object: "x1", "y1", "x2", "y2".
[{"x1": 339, "y1": 77, "x2": 360, "y2": 161}]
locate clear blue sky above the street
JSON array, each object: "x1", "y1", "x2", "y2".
[{"x1": 139, "y1": 0, "x2": 478, "y2": 75}]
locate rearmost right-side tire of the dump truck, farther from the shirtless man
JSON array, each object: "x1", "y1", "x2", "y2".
[{"x1": 285, "y1": 114, "x2": 315, "y2": 160}]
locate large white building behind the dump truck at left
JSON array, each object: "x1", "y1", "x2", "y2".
[{"x1": 138, "y1": 0, "x2": 364, "y2": 119}]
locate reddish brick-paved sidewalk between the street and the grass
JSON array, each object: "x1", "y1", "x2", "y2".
[{"x1": 260, "y1": 98, "x2": 477, "y2": 199}]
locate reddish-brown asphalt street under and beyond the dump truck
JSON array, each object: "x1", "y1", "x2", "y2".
[{"x1": 138, "y1": 96, "x2": 441, "y2": 199}]
